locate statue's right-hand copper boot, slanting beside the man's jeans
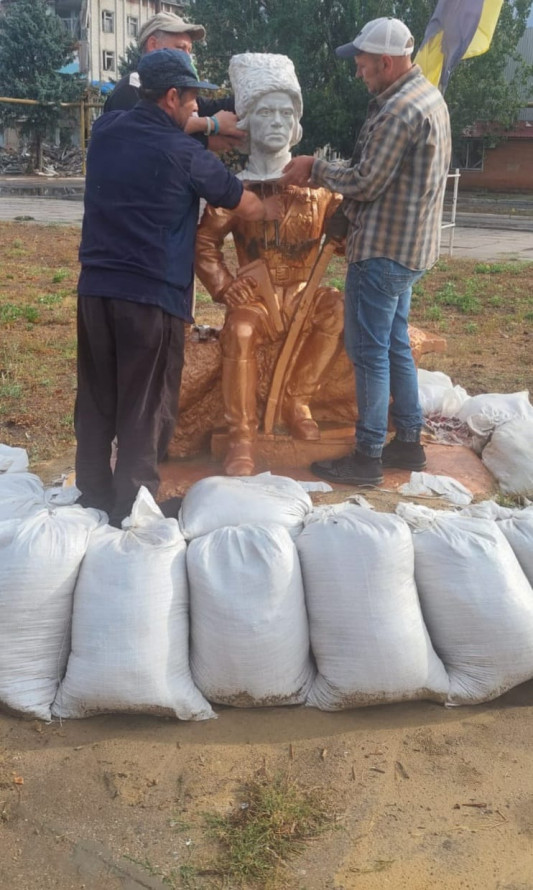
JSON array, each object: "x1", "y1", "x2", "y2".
[{"x1": 283, "y1": 330, "x2": 339, "y2": 441}]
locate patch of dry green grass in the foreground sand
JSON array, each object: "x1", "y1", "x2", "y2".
[{"x1": 205, "y1": 775, "x2": 332, "y2": 888}]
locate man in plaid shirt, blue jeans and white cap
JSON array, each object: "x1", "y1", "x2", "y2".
[{"x1": 282, "y1": 18, "x2": 451, "y2": 485}]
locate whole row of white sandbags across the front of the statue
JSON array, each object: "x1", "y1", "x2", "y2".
[{"x1": 0, "y1": 472, "x2": 533, "y2": 720}]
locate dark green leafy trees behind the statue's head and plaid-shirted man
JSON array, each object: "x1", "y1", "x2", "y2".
[{"x1": 190, "y1": 0, "x2": 531, "y2": 157}]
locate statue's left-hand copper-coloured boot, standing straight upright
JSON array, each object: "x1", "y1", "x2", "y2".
[{"x1": 222, "y1": 358, "x2": 257, "y2": 476}]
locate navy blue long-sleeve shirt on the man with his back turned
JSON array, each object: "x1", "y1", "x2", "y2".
[{"x1": 78, "y1": 100, "x2": 243, "y2": 322}]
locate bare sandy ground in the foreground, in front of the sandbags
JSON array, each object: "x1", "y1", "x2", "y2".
[{"x1": 0, "y1": 683, "x2": 533, "y2": 890}]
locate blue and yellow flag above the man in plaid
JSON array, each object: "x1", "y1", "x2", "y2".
[{"x1": 415, "y1": 0, "x2": 503, "y2": 92}]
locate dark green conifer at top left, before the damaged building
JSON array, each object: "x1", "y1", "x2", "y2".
[{"x1": 0, "y1": 0, "x2": 85, "y2": 169}]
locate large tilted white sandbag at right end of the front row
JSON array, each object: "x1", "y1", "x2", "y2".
[{"x1": 396, "y1": 504, "x2": 533, "y2": 704}]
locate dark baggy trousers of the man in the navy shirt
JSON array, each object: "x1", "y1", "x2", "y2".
[{"x1": 74, "y1": 297, "x2": 185, "y2": 525}]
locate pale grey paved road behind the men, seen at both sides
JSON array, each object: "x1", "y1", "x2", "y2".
[{"x1": 0, "y1": 195, "x2": 533, "y2": 261}]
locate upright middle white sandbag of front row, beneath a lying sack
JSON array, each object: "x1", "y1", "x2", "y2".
[{"x1": 187, "y1": 525, "x2": 314, "y2": 707}]
